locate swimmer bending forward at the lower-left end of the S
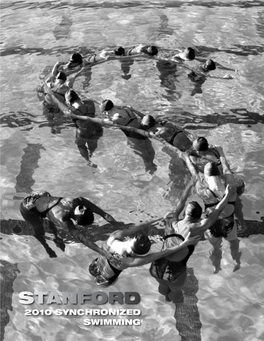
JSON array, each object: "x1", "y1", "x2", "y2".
[{"x1": 20, "y1": 191, "x2": 120, "y2": 258}]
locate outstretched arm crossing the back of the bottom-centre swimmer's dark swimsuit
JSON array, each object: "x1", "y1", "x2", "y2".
[{"x1": 121, "y1": 233, "x2": 200, "y2": 269}]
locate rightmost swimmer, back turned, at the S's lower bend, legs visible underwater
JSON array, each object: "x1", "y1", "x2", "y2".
[{"x1": 182, "y1": 147, "x2": 245, "y2": 273}]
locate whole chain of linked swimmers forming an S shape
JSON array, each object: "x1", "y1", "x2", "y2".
[{"x1": 20, "y1": 45, "x2": 245, "y2": 303}]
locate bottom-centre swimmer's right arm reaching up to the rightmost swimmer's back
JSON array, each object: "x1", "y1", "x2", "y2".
[{"x1": 189, "y1": 185, "x2": 236, "y2": 235}]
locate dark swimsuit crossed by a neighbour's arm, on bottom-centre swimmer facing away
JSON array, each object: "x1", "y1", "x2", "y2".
[{"x1": 149, "y1": 233, "x2": 195, "y2": 283}]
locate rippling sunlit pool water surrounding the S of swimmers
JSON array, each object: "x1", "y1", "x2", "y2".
[{"x1": 1, "y1": 0, "x2": 264, "y2": 341}]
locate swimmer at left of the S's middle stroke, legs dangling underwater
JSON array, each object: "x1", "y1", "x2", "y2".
[{"x1": 65, "y1": 90, "x2": 103, "y2": 168}]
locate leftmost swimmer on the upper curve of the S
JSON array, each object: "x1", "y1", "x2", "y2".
[{"x1": 43, "y1": 71, "x2": 70, "y2": 113}]
